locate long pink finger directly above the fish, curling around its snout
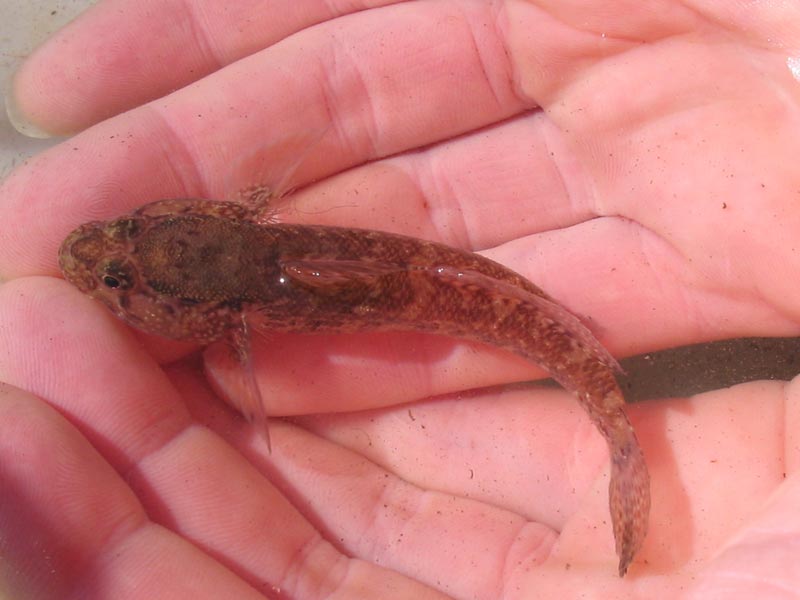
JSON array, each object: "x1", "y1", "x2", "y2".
[{"x1": 0, "y1": 2, "x2": 530, "y2": 277}]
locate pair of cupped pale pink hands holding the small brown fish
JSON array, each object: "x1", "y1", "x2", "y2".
[{"x1": 0, "y1": 1, "x2": 800, "y2": 599}]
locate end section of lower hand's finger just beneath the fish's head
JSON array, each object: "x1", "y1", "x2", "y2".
[{"x1": 0, "y1": 277, "x2": 190, "y2": 472}]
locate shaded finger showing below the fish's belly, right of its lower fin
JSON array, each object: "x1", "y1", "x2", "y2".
[{"x1": 242, "y1": 333, "x2": 543, "y2": 415}]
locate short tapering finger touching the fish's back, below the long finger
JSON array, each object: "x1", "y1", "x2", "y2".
[{"x1": 282, "y1": 111, "x2": 598, "y2": 251}]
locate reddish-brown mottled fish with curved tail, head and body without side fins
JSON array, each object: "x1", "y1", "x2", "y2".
[{"x1": 59, "y1": 199, "x2": 650, "y2": 576}]
